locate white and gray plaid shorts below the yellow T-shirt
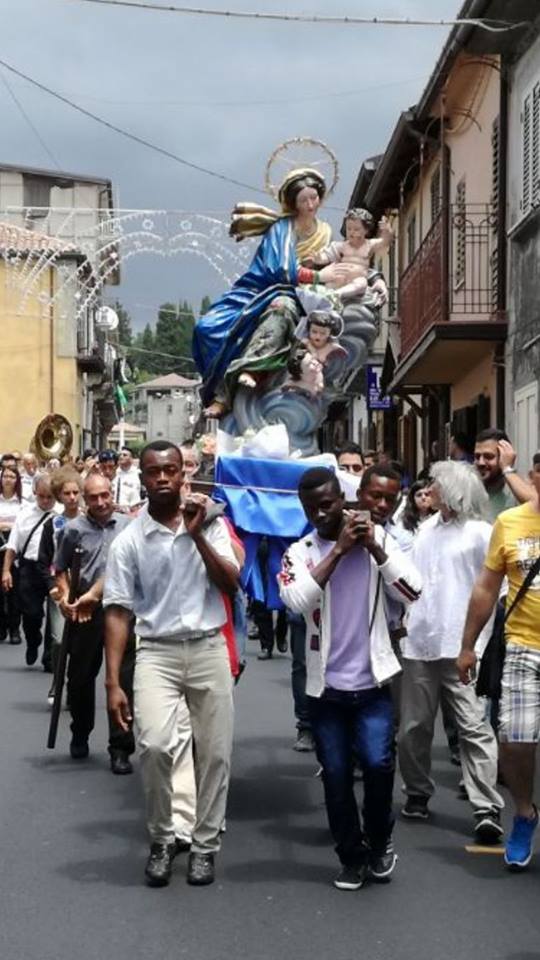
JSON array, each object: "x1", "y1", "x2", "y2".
[{"x1": 499, "y1": 643, "x2": 540, "y2": 743}]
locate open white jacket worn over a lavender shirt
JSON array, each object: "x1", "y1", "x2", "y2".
[{"x1": 278, "y1": 526, "x2": 422, "y2": 697}]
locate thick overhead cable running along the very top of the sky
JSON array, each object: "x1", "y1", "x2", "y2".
[{"x1": 69, "y1": 0, "x2": 530, "y2": 33}]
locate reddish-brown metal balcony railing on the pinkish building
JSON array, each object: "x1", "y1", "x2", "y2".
[{"x1": 398, "y1": 203, "x2": 499, "y2": 361}]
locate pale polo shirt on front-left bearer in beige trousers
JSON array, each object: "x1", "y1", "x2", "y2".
[{"x1": 103, "y1": 507, "x2": 238, "y2": 640}]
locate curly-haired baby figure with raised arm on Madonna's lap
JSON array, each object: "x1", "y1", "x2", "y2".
[{"x1": 304, "y1": 208, "x2": 394, "y2": 301}]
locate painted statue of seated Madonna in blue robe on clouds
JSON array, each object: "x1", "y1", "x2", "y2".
[{"x1": 193, "y1": 140, "x2": 386, "y2": 453}]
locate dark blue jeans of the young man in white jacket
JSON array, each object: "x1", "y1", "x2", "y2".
[{"x1": 307, "y1": 686, "x2": 395, "y2": 866}]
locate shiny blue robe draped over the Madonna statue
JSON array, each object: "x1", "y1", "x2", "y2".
[{"x1": 193, "y1": 217, "x2": 298, "y2": 403}]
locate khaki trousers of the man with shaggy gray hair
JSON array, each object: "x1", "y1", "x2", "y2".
[{"x1": 398, "y1": 659, "x2": 504, "y2": 811}]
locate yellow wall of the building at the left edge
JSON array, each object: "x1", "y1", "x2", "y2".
[{"x1": 0, "y1": 260, "x2": 81, "y2": 452}]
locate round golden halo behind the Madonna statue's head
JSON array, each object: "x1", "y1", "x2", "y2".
[{"x1": 264, "y1": 137, "x2": 339, "y2": 200}]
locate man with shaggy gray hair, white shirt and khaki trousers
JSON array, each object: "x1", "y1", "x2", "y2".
[{"x1": 398, "y1": 461, "x2": 503, "y2": 843}]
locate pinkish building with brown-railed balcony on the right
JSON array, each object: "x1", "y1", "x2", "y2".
[{"x1": 351, "y1": 0, "x2": 532, "y2": 475}]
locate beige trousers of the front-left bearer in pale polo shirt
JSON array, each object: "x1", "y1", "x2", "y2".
[{"x1": 133, "y1": 633, "x2": 233, "y2": 853}]
